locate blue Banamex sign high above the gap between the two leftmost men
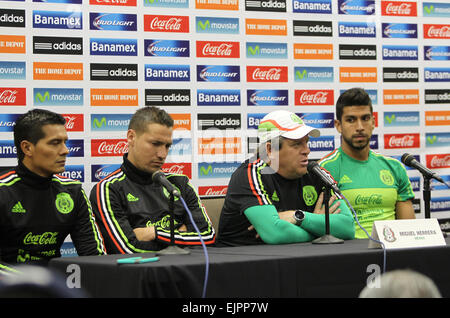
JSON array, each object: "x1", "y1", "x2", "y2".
[{"x1": 90, "y1": 38, "x2": 137, "y2": 56}]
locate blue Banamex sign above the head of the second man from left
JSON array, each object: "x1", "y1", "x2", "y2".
[{"x1": 145, "y1": 64, "x2": 191, "y2": 82}]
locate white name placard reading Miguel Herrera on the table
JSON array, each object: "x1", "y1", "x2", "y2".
[{"x1": 369, "y1": 219, "x2": 446, "y2": 249}]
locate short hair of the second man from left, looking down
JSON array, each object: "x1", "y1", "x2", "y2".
[{"x1": 128, "y1": 106, "x2": 173, "y2": 133}]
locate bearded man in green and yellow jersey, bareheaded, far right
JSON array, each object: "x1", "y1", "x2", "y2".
[{"x1": 319, "y1": 88, "x2": 415, "y2": 238}]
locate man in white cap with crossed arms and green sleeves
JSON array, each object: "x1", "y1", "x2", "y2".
[{"x1": 218, "y1": 110, "x2": 355, "y2": 246}]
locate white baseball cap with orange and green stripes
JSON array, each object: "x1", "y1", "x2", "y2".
[{"x1": 258, "y1": 110, "x2": 320, "y2": 142}]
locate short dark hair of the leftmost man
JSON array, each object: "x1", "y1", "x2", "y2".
[{"x1": 14, "y1": 108, "x2": 66, "y2": 161}]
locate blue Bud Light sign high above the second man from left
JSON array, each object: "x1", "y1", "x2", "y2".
[{"x1": 144, "y1": 40, "x2": 190, "y2": 57}]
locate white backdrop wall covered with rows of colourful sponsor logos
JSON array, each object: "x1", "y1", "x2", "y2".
[{"x1": 0, "y1": 0, "x2": 450, "y2": 234}]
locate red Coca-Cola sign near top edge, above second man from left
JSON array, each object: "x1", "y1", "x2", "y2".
[{"x1": 144, "y1": 15, "x2": 189, "y2": 33}]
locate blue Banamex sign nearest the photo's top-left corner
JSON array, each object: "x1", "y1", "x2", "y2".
[{"x1": 33, "y1": 11, "x2": 83, "y2": 30}]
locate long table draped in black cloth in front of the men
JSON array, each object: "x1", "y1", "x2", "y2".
[{"x1": 49, "y1": 238, "x2": 450, "y2": 298}]
